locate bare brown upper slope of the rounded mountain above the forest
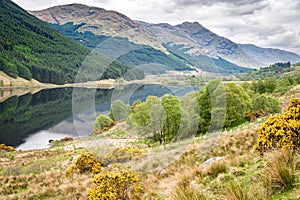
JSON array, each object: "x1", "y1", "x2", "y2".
[{"x1": 30, "y1": 4, "x2": 165, "y2": 51}]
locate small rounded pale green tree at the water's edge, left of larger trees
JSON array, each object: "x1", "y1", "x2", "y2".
[{"x1": 109, "y1": 100, "x2": 130, "y2": 121}]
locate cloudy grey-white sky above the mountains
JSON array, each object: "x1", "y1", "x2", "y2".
[{"x1": 13, "y1": 0, "x2": 300, "y2": 54}]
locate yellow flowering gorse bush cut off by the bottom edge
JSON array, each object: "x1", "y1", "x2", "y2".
[{"x1": 88, "y1": 170, "x2": 143, "y2": 200}]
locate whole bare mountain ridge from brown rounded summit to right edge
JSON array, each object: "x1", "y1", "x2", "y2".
[{"x1": 31, "y1": 4, "x2": 300, "y2": 72}]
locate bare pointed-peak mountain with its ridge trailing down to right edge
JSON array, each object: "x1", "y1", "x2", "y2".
[{"x1": 136, "y1": 21, "x2": 300, "y2": 68}]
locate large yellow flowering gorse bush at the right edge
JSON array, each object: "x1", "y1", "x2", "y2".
[{"x1": 254, "y1": 98, "x2": 300, "y2": 153}]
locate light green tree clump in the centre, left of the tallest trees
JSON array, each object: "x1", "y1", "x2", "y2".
[{"x1": 130, "y1": 95, "x2": 181, "y2": 144}]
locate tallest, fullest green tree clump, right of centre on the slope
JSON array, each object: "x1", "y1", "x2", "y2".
[{"x1": 198, "y1": 80, "x2": 251, "y2": 133}]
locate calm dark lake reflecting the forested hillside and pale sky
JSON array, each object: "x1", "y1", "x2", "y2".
[{"x1": 0, "y1": 85, "x2": 193, "y2": 150}]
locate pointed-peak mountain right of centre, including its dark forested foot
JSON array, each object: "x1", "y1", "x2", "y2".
[{"x1": 137, "y1": 21, "x2": 253, "y2": 73}]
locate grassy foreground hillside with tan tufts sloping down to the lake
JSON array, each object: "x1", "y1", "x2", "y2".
[{"x1": 0, "y1": 92, "x2": 300, "y2": 200}]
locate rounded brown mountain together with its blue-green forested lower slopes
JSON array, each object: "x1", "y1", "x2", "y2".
[{"x1": 31, "y1": 4, "x2": 249, "y2": 74}]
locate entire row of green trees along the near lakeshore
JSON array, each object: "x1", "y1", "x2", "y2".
[{"x1": 95, "y1": 79, "x2": 281, "y2": 144}]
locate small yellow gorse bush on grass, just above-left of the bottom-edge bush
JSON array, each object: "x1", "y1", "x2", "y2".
[{"x1": 66, "y1": 153, "x2": 103, "y2": 177}]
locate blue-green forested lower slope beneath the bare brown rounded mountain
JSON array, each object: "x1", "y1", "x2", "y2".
[{"x1": 49, "y1": 22, "x2": 192, "y2": 74}]
